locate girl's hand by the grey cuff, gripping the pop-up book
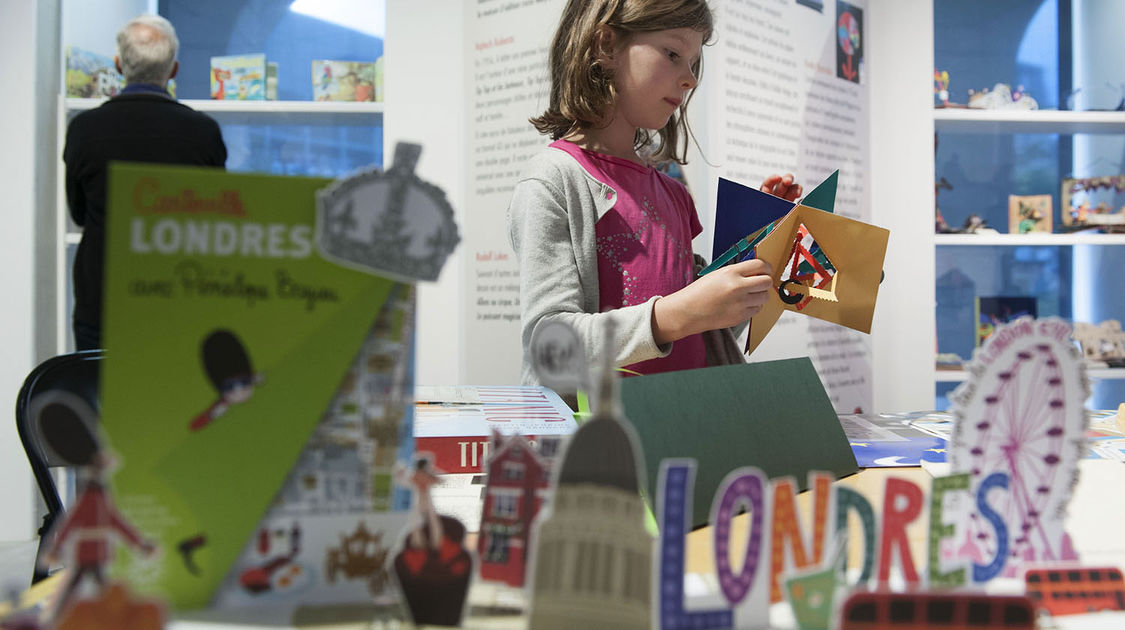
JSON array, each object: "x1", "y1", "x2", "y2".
[{"x1": 653, "y1": 259, "x2": 773, "y2": 344}]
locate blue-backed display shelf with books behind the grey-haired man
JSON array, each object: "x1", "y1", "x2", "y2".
[{"x1": 52, "y1": 0, "x2": 385, "y2": 352}]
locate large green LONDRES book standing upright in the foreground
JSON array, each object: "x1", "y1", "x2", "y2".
[{"x1": 95, "y1": 164, "x2": 423, "y2": 609}]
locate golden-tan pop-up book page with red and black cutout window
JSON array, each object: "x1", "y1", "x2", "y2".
[{"x1": 746, "y1": 206, "x2": 890, "y2": 352}]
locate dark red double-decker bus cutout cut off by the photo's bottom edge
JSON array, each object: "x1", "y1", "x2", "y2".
[{"x1": 839, "y1": 592, "x2": 1035, "y2": 630}]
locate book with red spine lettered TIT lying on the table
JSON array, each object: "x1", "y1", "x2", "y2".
[{"x1": 414, "y1": 386, "x2": 578, "y2": 475}]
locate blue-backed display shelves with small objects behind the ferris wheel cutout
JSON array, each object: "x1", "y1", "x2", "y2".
[{"x1": 933, "y1": 0, "x2": 1125, "y2": 408}]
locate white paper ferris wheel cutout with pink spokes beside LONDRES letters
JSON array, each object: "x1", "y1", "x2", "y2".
[{"x1": 952, "y1": 318, "x2": 1087, "y2": 575}]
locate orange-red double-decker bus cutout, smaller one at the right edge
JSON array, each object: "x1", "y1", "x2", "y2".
[{"x1": 1024, "y1": 567, "x2": 1125, "y2": 615}]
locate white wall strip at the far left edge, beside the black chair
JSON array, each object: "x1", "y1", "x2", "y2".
[{"x1": 0, "y1": 0, "x2": 57, "y2": 541}]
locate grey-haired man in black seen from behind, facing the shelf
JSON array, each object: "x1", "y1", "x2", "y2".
[{"x1": 63, "y1": 16, "x2": 226, "y2": 350}]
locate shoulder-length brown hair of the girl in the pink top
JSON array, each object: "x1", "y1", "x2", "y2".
[{"x1": 531, "y1": 0, "x2": 713, "y2": 164}]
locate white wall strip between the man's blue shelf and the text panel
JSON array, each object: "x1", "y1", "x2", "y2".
[{"x1": 384, "y1": 0, "x2": 469, "y2": 385}]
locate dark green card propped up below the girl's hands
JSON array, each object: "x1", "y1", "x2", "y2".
[{"x1": 621, "y1": 358, "x2": 858, "y2": 527}]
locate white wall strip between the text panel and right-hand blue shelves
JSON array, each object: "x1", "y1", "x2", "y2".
[{"x1": 866, "y1": 0, "x2": 937, "y2": 412}]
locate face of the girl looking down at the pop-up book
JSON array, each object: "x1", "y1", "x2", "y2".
[{"x1": 612, "y1": 28, "x2": 703, "y2": 129}]
